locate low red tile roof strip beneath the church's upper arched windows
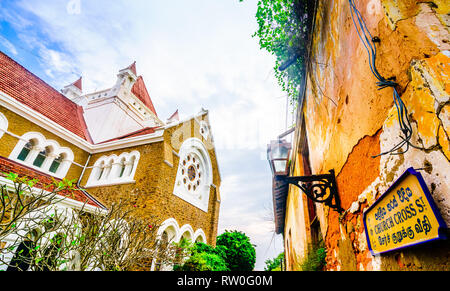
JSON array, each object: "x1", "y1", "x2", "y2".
[{"x1": 0, "y1": 156, "x2": 104, "y2": 208}]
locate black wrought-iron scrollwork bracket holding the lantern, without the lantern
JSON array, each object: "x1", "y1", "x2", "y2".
[{"x1": 285, "y1": 170, "x2": 344, "y2": 213}]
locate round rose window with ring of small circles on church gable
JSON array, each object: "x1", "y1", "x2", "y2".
[{"x1": 181, "y1": 153, "x2": 203, "y2": 198}]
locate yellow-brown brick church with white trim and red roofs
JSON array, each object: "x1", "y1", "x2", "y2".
[{"x1": 0, "y1": 52, "x2": 221, "y2": 269}]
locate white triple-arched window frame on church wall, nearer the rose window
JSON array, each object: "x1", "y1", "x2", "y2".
[{"x1": 85, "y1": 151, "x2": 141, "y2": 188}]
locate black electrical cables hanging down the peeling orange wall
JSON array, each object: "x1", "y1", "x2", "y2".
[{"x1": 348, "y1": 0, "x2": 412, "y2": 158}]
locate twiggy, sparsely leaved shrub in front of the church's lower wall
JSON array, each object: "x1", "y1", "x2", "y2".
[{"x1": 0, "y1": 174, "x2": 176, "y2": 271}]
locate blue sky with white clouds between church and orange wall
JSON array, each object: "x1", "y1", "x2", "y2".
[{"x1": 0, "y1": 0, "x2": 292, "y2": 270}]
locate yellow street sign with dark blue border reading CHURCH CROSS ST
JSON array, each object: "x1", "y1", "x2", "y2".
[{"x1": 363, "y1": 168, "x2": 447, "y2": 255}]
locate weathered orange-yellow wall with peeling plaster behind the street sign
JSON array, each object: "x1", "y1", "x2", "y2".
[{"x1": 288, "y1": 0, "x2": 450, "y2": 270}]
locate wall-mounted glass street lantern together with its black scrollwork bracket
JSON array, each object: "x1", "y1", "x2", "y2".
[{"x1": 267, "y1": 140, "x2": 344, "y2": 213}]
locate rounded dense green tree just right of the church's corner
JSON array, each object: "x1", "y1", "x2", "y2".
[{"x1": 216, "y1": 231, "x2": 256, "y2": 271}]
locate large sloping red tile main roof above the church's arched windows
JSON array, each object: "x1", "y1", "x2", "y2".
[{"x1": 0, "y1": 51, "x2": 92, "y2": 142}]
